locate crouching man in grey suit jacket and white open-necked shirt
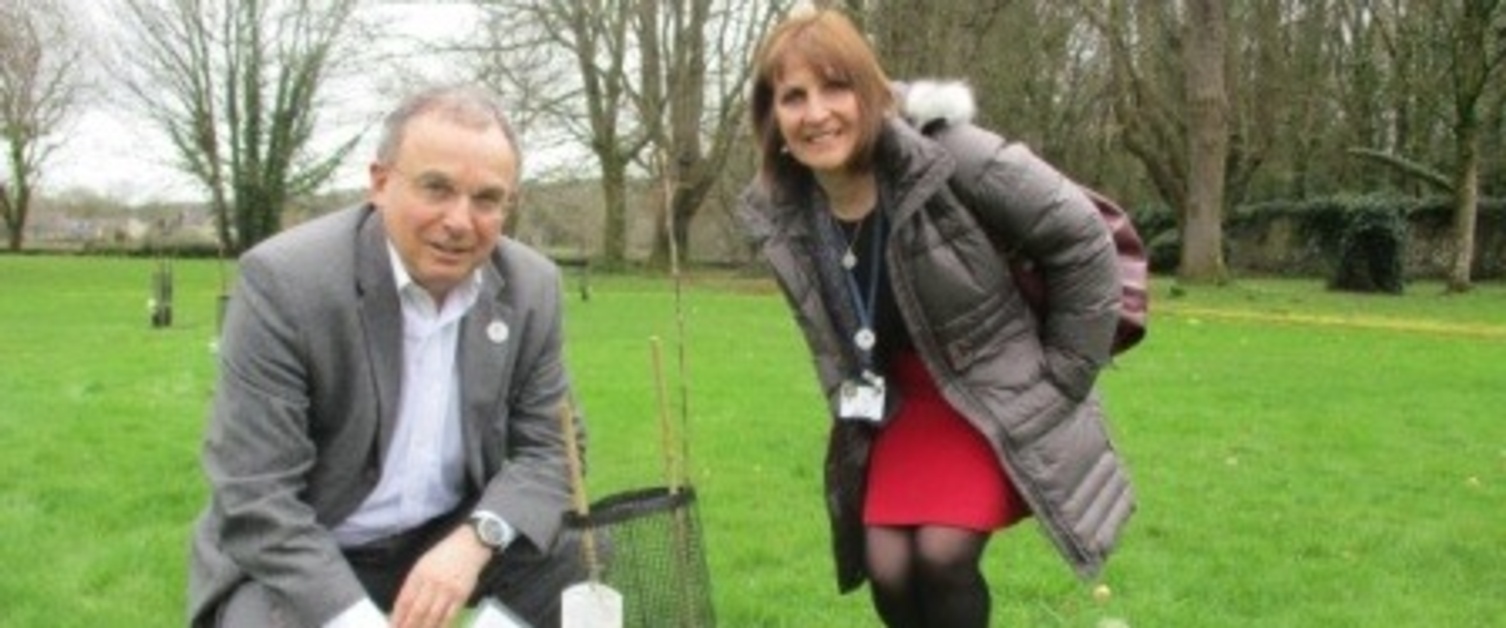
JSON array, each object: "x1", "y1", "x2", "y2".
[{"x1": 188, "y1": 87, "x2": 586, "y2": 628}]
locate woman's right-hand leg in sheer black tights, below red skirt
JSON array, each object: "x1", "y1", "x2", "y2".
[{"x1": 909, "y1": 526, "x2": 991, "y2": 628}]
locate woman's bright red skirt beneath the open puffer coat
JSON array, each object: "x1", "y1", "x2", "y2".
[{"x1": 863, "y1": 351, "x2": 1029, "y2": 532}]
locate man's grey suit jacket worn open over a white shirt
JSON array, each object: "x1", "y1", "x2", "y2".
[{"x1": 188, "y1": 206, "x2": 584, "y2": 625}]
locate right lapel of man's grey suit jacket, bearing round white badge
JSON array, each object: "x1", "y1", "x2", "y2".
[{"x1": 458, "y1": 253, "x2": 520, "y2": 486}]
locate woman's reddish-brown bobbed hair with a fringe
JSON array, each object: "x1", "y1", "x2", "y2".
[{"x1": 751, "y1": 9, "x2": 895, "y2": 188}]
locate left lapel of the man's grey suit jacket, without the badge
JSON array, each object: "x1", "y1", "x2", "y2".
[{"x1": 355, "y1": 209, "x2": 402, "y2": 462}]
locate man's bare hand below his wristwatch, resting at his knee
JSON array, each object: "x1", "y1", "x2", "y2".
[{"x1": 392, "y1": 526, "x2": 492, "y2": 628}]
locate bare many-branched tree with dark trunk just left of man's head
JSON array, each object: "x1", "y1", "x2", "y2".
[{"x1": 115, "y1": 0, "x2": 358, "y2": 252}]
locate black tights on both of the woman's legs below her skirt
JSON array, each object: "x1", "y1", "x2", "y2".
[{"x1": 867, "y1": 526, "x2": 991, "y2": 628}]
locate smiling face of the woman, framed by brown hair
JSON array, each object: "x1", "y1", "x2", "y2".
[{"x1": 774, "y1": 59, "x2": 861, "y2": 175}]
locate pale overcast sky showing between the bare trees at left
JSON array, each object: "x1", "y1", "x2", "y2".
[{"x1": 41, "y1": 0, "x2": 476, "y2": 205}]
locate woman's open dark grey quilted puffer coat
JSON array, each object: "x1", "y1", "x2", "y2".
[{"x1": 739, "y1": 84, "x2": 1134, "y2": 592}]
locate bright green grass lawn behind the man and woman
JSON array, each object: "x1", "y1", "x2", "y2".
[{"x1": 0, "y1": 256, "x2": 1506, "y2": 626}]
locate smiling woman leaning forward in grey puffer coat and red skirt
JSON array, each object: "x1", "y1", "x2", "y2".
[{"x1": 739, "y1": 11, "x2": 1134, "y2": 626}]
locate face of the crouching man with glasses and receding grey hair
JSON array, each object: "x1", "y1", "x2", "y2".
[{"x1": 370, "y1": 113, "x2": 518, "y2": 303}]
